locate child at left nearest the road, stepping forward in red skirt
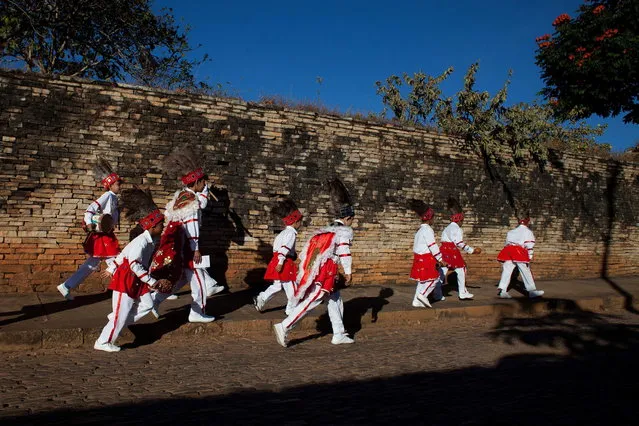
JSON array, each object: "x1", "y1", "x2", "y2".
[{"x1": 93, "y1": 189, "x2": 171, "y2": 352}]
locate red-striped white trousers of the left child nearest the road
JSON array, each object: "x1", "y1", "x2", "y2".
[{"x1": 97, "y1": 291, "x2": 153, "y2": 343}]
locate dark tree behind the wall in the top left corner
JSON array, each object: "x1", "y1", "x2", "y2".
[{"x1": 0, "y1": 0, "x2": 209, "y2": 90}]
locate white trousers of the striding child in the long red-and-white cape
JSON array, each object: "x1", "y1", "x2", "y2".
[{"x1": 282, "y1": 285, "x2": 346, "y2": 336}]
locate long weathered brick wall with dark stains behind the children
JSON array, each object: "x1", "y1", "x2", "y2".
[{"x1": 0, "y1": 71, "x2": 639, "y2": 292}]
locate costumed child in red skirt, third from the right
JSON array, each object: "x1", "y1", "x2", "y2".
[{"x1": 410, "y1": 202, "x2": 445, "y2": 308}]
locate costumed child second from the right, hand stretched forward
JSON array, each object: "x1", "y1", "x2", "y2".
[{"x1": 440, "y1": 198, "x2": 481, "y2": 300}]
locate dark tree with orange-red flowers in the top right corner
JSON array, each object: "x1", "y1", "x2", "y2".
[{"x1": 536, "y1": 0, "x2": 639, "y2": 124}]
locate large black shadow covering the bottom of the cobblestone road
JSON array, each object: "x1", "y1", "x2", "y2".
[{"x1": 3, "y1": 302, "x2": 639, "y2": 426}]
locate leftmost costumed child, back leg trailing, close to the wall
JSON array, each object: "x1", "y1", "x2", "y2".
[{"x1": 57, "y1": 158, "x2": 122, "y2": 300}]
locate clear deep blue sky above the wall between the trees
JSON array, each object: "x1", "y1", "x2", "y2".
[{"x1": 154, "y1": 0, "x2": 639, "y2": 151}]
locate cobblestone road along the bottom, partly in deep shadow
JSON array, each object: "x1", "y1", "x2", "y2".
[{"x1": 0, "y1": 312, "x2": 639, "y2": 425}]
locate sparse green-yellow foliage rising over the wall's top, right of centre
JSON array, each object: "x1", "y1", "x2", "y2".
[{"x1": 376, "y1": 63, "x2": 610, "y2": 174}]
